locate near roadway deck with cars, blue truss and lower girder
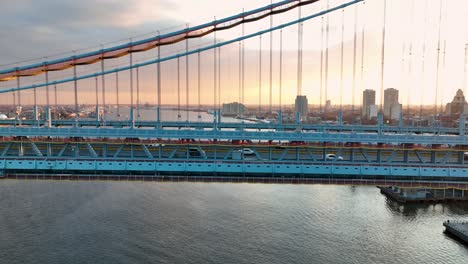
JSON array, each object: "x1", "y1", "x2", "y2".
[{"x1": 0, "y1": 138, "x2": 468, "y2": 182}]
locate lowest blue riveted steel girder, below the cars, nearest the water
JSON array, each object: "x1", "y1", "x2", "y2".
[{"x1": 0, "y1": 157, "x2": 468, "y2": 178}]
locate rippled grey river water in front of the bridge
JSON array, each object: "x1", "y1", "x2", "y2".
[{"x1": 0, "y1": 180, "x2": 468, "y2": 263}]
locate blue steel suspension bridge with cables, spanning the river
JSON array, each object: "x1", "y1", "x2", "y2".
[{"x1": 0, "y1": 0, "x2": 468, "y2": 189}]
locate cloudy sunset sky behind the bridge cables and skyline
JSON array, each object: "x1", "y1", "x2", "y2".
[{"x1": 0, "y1": 0, "x2": 468, "y2": 108}]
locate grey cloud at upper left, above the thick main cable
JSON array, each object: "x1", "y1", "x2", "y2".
[{"x1": 0, "y1": 0, "x2": 177, "y2": 65}]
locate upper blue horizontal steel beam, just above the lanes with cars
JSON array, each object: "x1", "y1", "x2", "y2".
[{"x1": 0, "y1": 127, "x2": 468, "y2": 145}]
